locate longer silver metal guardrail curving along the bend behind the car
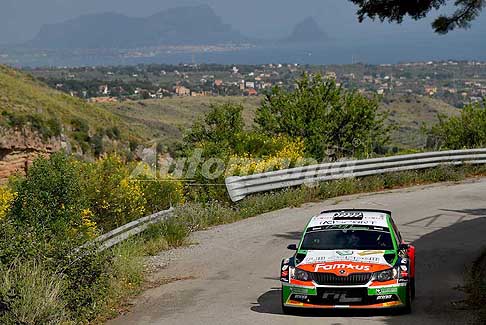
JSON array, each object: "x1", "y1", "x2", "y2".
[{"x1": 225, "y1": 149, "x2": 486, "y2": 202}]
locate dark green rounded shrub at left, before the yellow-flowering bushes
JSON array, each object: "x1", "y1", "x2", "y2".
[{"x1": 7, "y1": 153, "x2": 93, "y2": 258}]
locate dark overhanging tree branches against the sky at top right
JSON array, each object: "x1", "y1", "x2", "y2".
[{"x1": 349, "y1": 0, "x2": 486, "y2": 34}]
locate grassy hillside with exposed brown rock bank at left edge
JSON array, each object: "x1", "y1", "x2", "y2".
[{"x1": 0, "y1": 65, "x2": 141, "y2": 179}]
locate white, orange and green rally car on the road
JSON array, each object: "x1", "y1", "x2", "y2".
[{"x1": 280, "y1": 209, "x2": 415, "y2": 313}]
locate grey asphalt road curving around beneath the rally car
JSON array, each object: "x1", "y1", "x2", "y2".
[{"x1": 110, "y1": 179, "x2": 486, "y2": 325}]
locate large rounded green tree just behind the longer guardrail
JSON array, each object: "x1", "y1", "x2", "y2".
[{"x1": 255, "y1": 74, "x2": 389, "y2": 159}]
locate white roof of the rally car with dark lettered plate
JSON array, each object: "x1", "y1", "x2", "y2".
[{"x1": 307, "y1": 209, "x2": 391, "y2": 228}]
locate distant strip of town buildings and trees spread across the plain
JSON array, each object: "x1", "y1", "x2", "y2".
[{"x1": 29, "y1": 61, "x2": 486, "y2": 107}]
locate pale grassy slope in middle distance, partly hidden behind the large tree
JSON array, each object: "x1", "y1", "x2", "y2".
[{"x1": 104, "y1": 95, "x2": 460, "y2": 148}]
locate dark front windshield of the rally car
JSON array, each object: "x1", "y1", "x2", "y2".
[{"x1": 300, "y1": 229, "x2": 393, "y2": 250}]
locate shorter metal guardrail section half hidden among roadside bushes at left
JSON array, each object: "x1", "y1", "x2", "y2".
[{"x1": 81, "y1": 208, "x2": 174, "y2": 252}]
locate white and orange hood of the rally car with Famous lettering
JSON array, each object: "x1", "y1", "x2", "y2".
[{"x1": 297, "y1": 250, "x2": 391, "y2": 274}]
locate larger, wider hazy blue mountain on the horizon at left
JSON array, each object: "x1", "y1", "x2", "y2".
[{"x1": 28, "y1": 5, "x2": 245, "y2": 49}]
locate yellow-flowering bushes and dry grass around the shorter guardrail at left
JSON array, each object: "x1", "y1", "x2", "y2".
[{"x1": 0, "y1": 153, "x2": 182, "y2": 324}]
